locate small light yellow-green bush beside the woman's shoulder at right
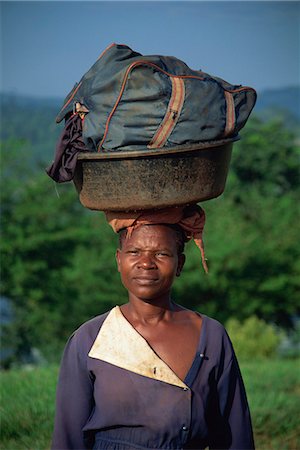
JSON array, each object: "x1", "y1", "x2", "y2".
[{"x1": 226, "y1": 316, "x2": 284, "y2": 361}]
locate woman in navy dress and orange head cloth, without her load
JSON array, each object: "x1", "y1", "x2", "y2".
[{"x1": 52, "y1": 205, "x2": 254, "y2": 450}]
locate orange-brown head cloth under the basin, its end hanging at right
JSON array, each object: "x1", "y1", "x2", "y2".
[{"x1": 105, "y1": 205, "x2": 208, "y2": 273}]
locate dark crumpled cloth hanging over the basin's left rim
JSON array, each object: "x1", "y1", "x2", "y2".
[{"x1": 46, "y1": 114, "x2": 89, "y2": 183}]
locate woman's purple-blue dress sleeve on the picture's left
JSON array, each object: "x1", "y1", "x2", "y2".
[{"x1": 51, "y1": 332, "x2": 94, "y2": 450}]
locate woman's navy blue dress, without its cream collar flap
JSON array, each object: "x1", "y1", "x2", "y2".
[{"x1": 52, "y1": 313, "x2": 254, "y2": 450}]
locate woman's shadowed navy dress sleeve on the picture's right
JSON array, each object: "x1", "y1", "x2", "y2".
[{"x1": 210, "y1": 353, "x2": 255, "y2": 450}]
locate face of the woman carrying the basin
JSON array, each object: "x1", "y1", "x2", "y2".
[{"x1": 116, "y1": 225, "x2": 185, "y2": 301}]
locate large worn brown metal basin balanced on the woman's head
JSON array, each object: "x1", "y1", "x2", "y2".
[{"x1": 74, "y1": 137, "x2": 239, "y2": 211}]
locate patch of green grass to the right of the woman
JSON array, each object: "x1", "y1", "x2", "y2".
[{"x1": 241, "y1": 355, "x2": 300, "y2": 450}]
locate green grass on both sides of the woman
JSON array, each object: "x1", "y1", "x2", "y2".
[{"x1": 1, "y1": 359, "x2": 300, "y2": 450}]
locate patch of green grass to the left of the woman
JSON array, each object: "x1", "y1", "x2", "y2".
[{"x1": 0, "y1": 367, "x2": 57, "y2": 450}]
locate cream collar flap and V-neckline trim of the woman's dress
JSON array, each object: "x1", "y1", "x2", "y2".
[{"x1": 89, "y1": 306, "x2": 205, "y2": 388}]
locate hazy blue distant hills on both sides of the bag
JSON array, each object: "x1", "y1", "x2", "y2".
[{"x1": 0, "y1": 86, "x2": 300, "y2": 164}]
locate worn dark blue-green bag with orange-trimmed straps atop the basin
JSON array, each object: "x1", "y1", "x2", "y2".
[{"x1": 57, "y1": 44, "x2": 256, "y2": 151}]
